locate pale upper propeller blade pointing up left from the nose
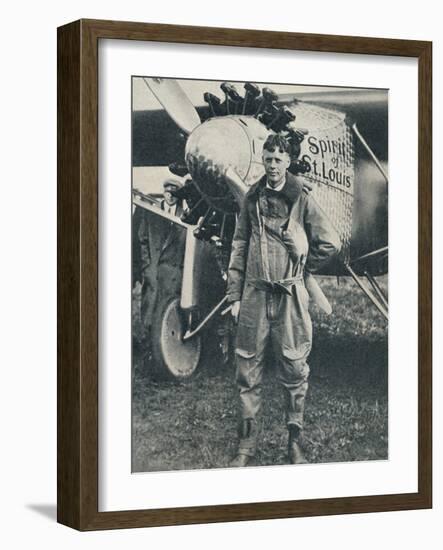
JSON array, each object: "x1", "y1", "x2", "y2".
[{"x1": 143, "y1": 78, "x2": 201, "y2": 134}]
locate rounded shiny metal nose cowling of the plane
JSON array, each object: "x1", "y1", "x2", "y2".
[{"x1": 185, "y1": 116, "x2": 269, "y2": 211}]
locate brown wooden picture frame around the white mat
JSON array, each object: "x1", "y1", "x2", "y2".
[{"x1": 57, "y1": 20, "x2": 432, "y2": 530}]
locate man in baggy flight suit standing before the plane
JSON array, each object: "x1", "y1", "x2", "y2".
[{"x1": 228, "y1": 134, "x2": 341, "y2": 466}]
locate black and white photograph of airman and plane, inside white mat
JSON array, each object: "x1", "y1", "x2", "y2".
[{"x1": 132, "y1": 75, "x2": 389, "y2": 472}]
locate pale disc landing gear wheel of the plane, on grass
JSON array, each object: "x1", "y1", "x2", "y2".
[{"x1": 152, "y1": 298, "x2": 201, "y2": 380}]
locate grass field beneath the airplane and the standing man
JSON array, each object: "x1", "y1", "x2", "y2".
[{"x1": 132, "y1": 277, "x2": 388, "y2": 472}]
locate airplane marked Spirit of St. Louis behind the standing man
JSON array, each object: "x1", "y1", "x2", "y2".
[{"x1": 132, "y1": 77, "x2": 388, "y2": 379}]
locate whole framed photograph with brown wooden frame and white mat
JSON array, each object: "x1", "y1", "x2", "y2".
[{"x1": 58, "y1": 20, "x2": 432, "y2": 530}]
